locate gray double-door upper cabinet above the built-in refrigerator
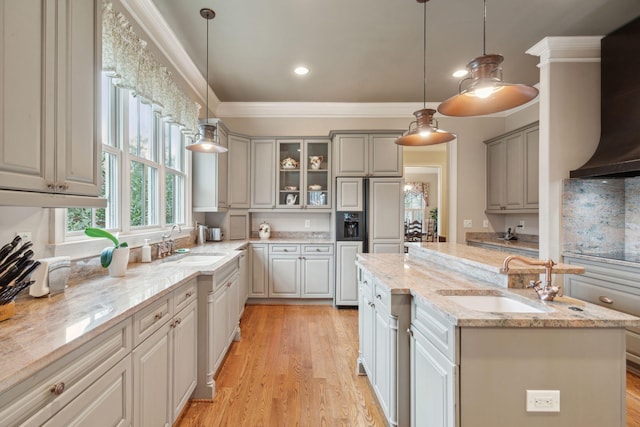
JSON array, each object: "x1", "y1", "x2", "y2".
[{"x1": 333, "y1": 133, "x2": 402, "y2": 177}]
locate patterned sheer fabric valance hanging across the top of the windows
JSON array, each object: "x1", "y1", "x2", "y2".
[{"x1": 102, "y1": 3, "x2": 200, "y2": 133}]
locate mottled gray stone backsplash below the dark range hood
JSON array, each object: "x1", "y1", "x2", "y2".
[{"x1": 562, "y1": 177, "x2": 640, "y2": 255}]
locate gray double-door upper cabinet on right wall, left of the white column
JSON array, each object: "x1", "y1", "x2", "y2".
[{"x1": 485, "y1": 122, "x2": 539, "y2": 213}]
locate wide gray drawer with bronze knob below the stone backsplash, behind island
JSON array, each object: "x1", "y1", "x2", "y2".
[{"x1": 566, "y1": 276, "x2": 640, "y2": 316}]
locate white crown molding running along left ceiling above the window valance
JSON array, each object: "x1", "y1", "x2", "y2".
[{"x1": 120, "y1": 0, "x2": 220, "y2": 111}]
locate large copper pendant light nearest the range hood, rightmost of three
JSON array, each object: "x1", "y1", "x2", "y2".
[{"x1": 438, "y1": 0, "x2": 538, "y2": 117}]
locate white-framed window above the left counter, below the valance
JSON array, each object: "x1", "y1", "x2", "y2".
[{"x1": 66, "y1": 73, "x2": 188, "y2": 237}]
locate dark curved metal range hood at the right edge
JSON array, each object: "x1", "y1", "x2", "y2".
[{"x1": 570, "y1": 17, "x2": 640, "y2": 178}]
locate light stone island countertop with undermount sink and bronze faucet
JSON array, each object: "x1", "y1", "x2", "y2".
[{"x1": 357, "y1": 243, "x2": 640, "y2": 328}]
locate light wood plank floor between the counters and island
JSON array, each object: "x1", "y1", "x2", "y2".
[{"x1": 176, "y1": 305, "x2": 640, "y2": 427}]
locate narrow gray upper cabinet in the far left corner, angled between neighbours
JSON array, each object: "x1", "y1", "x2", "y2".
[{"x1": 228, "y1": 135, "x2": 251, "y2": 209}]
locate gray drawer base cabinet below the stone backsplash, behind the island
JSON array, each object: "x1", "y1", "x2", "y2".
[{"x1": 564, "y1": 256, "x2": 640, "y2": 373}]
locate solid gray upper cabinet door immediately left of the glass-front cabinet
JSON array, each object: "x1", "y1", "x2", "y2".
[{"x1": 251, "y1": 139, "x2": 277, "y2": 209}]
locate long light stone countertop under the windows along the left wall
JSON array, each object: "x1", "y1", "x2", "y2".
[{"x1": 0, "y1": 241, "x2": 247, "y2": 391}]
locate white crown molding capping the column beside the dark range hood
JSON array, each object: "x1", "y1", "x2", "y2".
[{"x1": 527, "y1": 36, "x2": 603, "y2": 66}]
